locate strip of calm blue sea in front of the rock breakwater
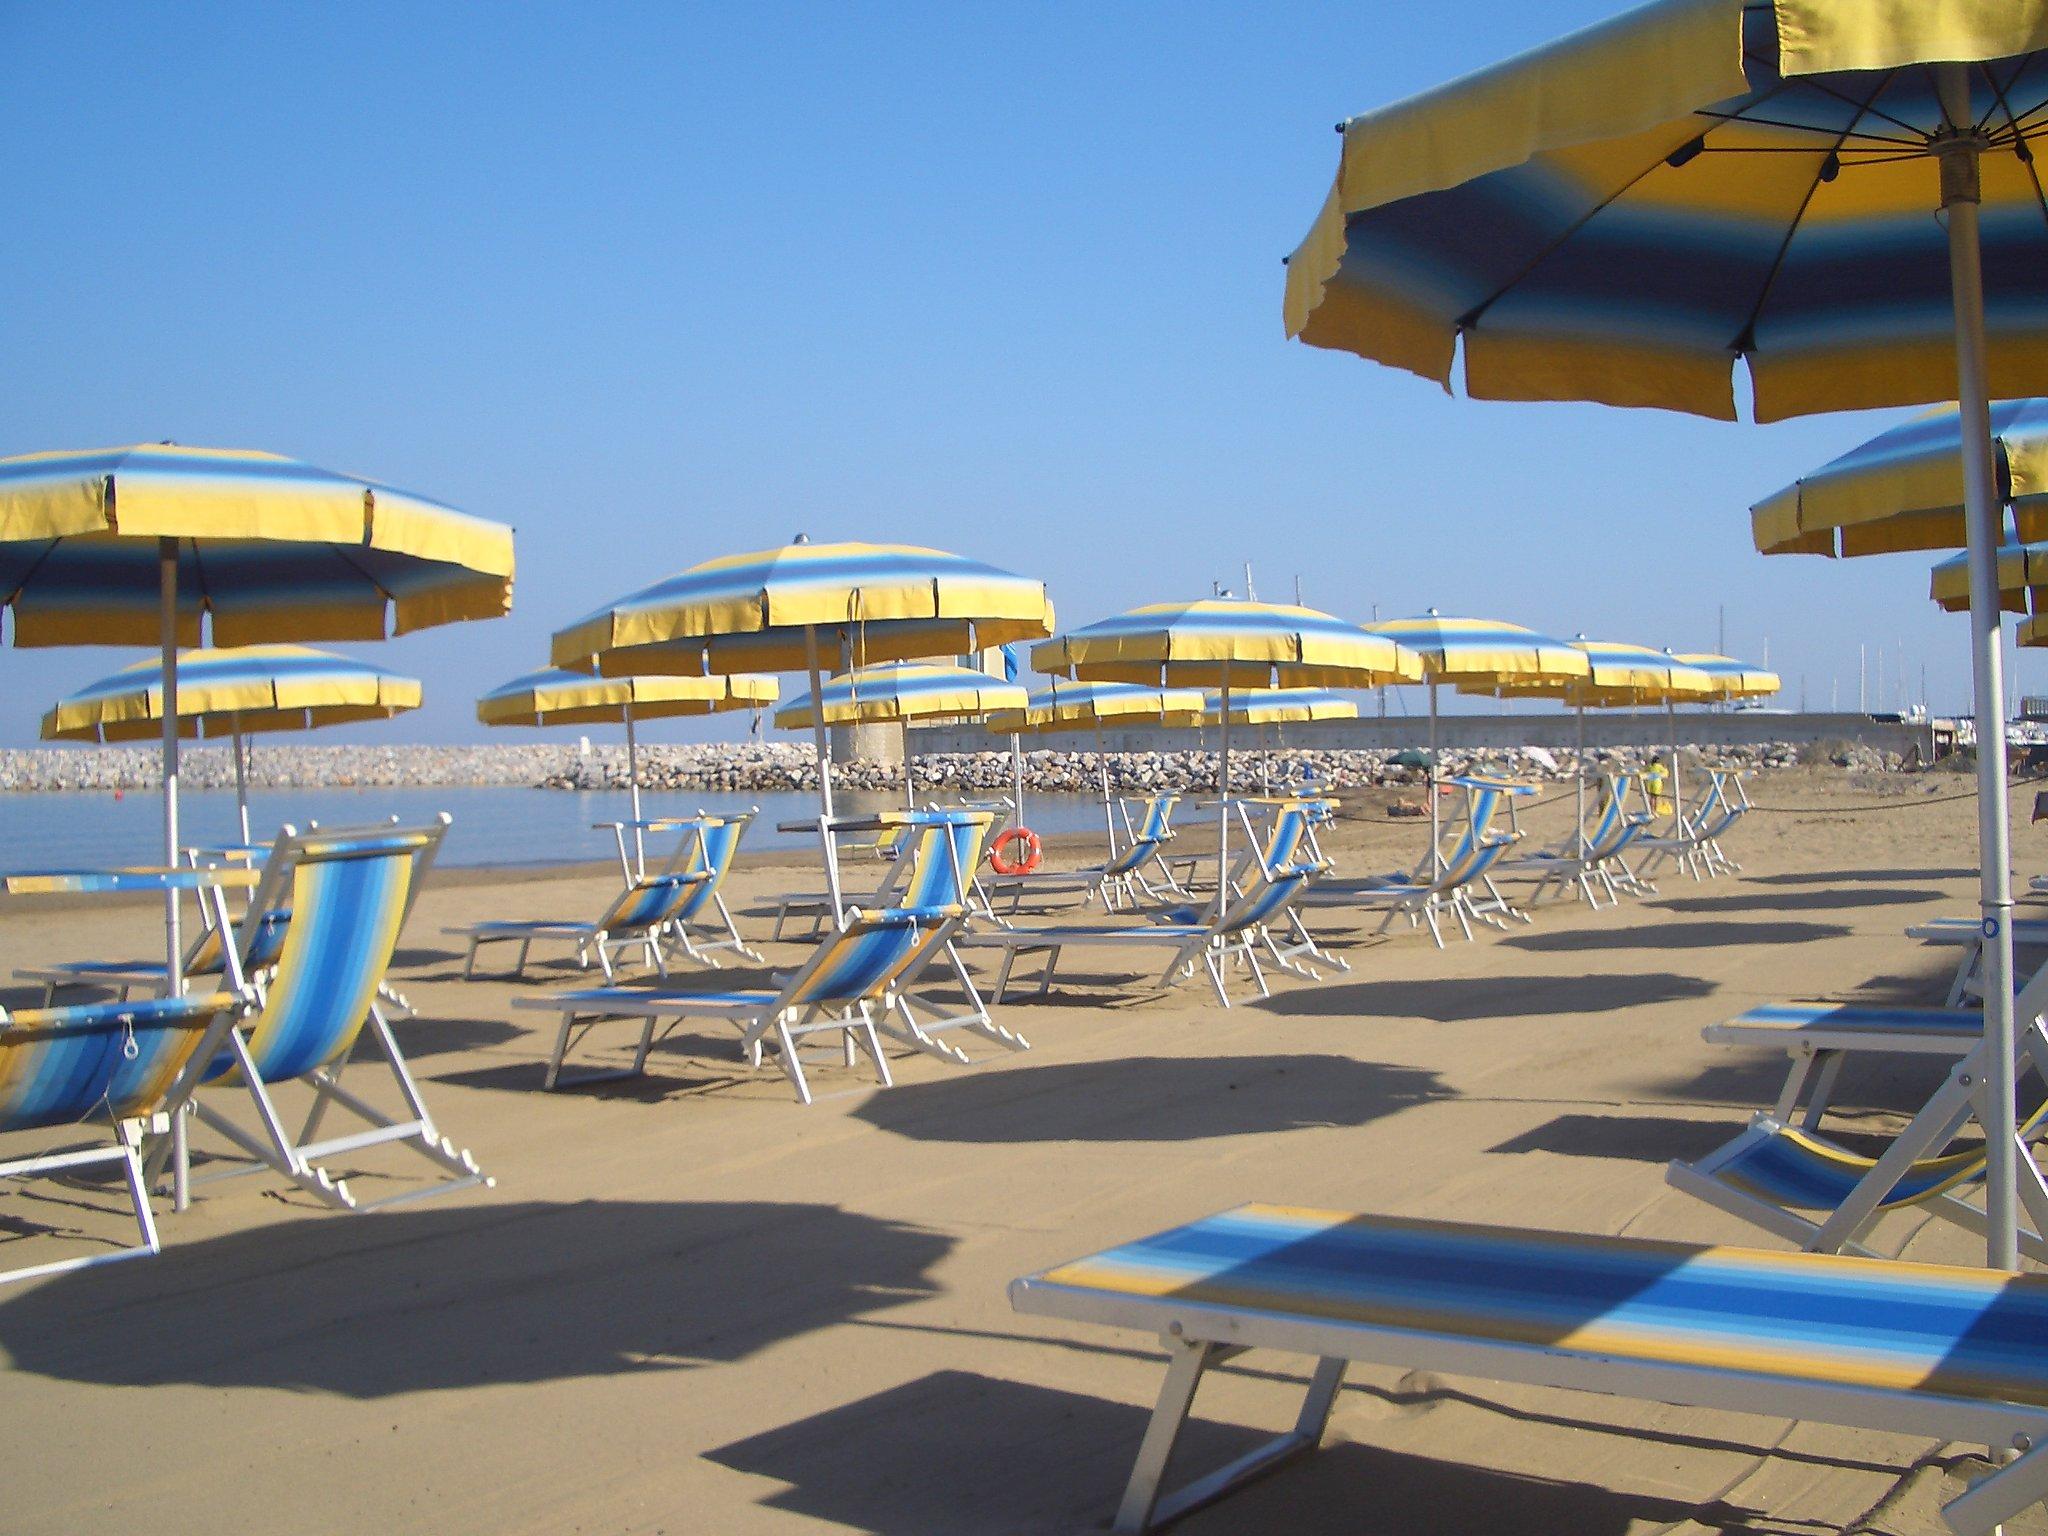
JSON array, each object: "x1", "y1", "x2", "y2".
[{"x1": 0, "y1": 788, "x2": 1102, "y2": 870}]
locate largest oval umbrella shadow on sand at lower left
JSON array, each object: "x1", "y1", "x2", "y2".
[{"x1": 0, "y1": 1200, "x2": 952, "y2": 1399}]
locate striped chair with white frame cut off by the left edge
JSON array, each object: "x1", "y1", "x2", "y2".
[{"x1": 0, "y1": 991, "x2": 242, "y2": 1282}]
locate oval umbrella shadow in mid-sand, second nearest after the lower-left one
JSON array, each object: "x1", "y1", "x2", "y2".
[{"x1": 854, "y1": 1055, "x2": 1452, "y2": 1143}]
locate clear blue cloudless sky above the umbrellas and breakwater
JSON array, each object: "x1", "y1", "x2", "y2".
[{"x1": 0, "y1": 0, "x2": 2015, "y2": 743}]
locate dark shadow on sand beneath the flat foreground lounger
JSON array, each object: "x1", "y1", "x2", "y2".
[{"x1": 707, "y1": 1370, "x2": 1753, "y2": 1536}]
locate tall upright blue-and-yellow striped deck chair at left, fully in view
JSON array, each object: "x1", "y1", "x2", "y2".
[{"x1": 152, "y1": 825, "x2": 494, "y2": 1210}]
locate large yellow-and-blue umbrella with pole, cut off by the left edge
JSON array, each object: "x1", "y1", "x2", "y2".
[{"x1": 0, "y1": 442, "x2": 512, "y2": 991}]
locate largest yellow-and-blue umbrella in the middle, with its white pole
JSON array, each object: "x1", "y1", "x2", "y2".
[{"x1": 551, "y1": 535, "x2": 1053, "y2": 925}]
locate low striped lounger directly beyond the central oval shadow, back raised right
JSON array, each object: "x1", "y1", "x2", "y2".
[{"x1": 954, "y1": 843, "x2": 1323, "y2": 1008}]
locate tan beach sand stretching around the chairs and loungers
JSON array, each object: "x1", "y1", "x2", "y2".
[{"x1": 0, "y1": 774, "x2": 2040, "y2": 1536}]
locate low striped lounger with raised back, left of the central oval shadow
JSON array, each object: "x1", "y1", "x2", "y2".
[{"x1": 512, "y1": 907, "x2": 967, "y2": 1104}]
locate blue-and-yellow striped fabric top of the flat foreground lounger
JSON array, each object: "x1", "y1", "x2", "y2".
[{"x1": 1028, "y1": 1206, "x2": 2048, "y2": 1405}]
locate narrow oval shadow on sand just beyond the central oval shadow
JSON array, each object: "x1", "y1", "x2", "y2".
[{"x1": 1253, "y1": 971, "x2": 1716, "y2": 1024}]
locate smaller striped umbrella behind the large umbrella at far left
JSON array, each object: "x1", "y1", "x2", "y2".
[{"x1": 43, "y1": 645, "x2": 420, "y2": 846}]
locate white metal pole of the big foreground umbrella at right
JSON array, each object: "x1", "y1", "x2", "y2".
[{"x1": 1935, "y1": 63, "x2": 2019, "y2": 1270}]
